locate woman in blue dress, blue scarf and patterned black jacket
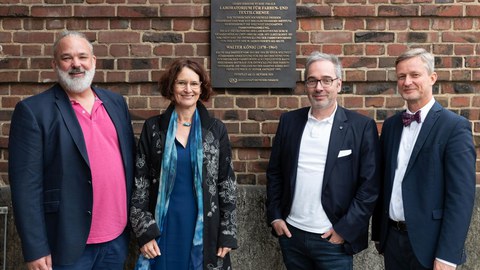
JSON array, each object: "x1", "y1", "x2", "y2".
[{"x1": 130, "y1": 59, "x2": 237, "y2": 270}]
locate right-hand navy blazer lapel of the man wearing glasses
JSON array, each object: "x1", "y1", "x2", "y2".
[{"x1": 323, "y1": 106, "x2": 350, "y2": 187}]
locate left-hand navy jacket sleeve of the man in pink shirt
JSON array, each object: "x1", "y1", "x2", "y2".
[{"x1": 8, "y1": 102, "x2": 50, "y2": 262}]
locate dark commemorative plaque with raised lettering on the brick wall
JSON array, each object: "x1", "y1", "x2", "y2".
[{"x1": 211, "y1": 0, "x2": 297, "y2": 88}]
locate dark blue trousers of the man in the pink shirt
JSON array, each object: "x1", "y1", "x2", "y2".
[{"x1": 53, "y1": 229, "x2": 130, "y2": 270}]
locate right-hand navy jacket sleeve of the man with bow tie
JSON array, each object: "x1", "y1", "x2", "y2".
[{"x1": 435, "y1": 118, "x2": 476, "y2": 264}]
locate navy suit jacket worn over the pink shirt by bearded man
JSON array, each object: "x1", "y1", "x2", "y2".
[{"x1": 9, "y1": 84, "x2": 135, "y2": 265}]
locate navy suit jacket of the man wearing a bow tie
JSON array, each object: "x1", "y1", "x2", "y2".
[{"x1": 372, "y1": 103, "x2": 476, "y2": 268}]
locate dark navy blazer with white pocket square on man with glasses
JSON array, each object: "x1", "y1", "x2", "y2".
[{"x1": 267, "y1": 106, "x2": 380, "y2": 254}]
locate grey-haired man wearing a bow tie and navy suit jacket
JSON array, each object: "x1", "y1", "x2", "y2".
[{"x1": 372, "y1": 49, "x2": 476, "y2": 270}]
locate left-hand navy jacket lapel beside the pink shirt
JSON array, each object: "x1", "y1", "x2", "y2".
[{"x1": 55, "y1": 84, "x2": 90, "y2": 166}]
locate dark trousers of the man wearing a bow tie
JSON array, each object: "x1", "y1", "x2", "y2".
[{"x1": 383, "y1": 227, "x2": 433, "y2": 270}]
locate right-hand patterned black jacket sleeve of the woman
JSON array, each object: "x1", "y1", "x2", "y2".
[{"x1": 217, "y1": 121, "x2": 238, "y2": 249}]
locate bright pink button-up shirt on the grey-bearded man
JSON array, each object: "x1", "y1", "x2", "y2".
[{"x1": 71, "y1": 97, "x2": 127, "y2": 244}]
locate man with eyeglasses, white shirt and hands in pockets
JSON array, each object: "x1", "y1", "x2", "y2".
[{"x1": 266, "y1": 52, "x2": 380, "y2": 270}]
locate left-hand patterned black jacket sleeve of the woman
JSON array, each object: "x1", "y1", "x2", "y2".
[{"x1": 130, "y1": 120, "x2": 160, "y2": 247}]
